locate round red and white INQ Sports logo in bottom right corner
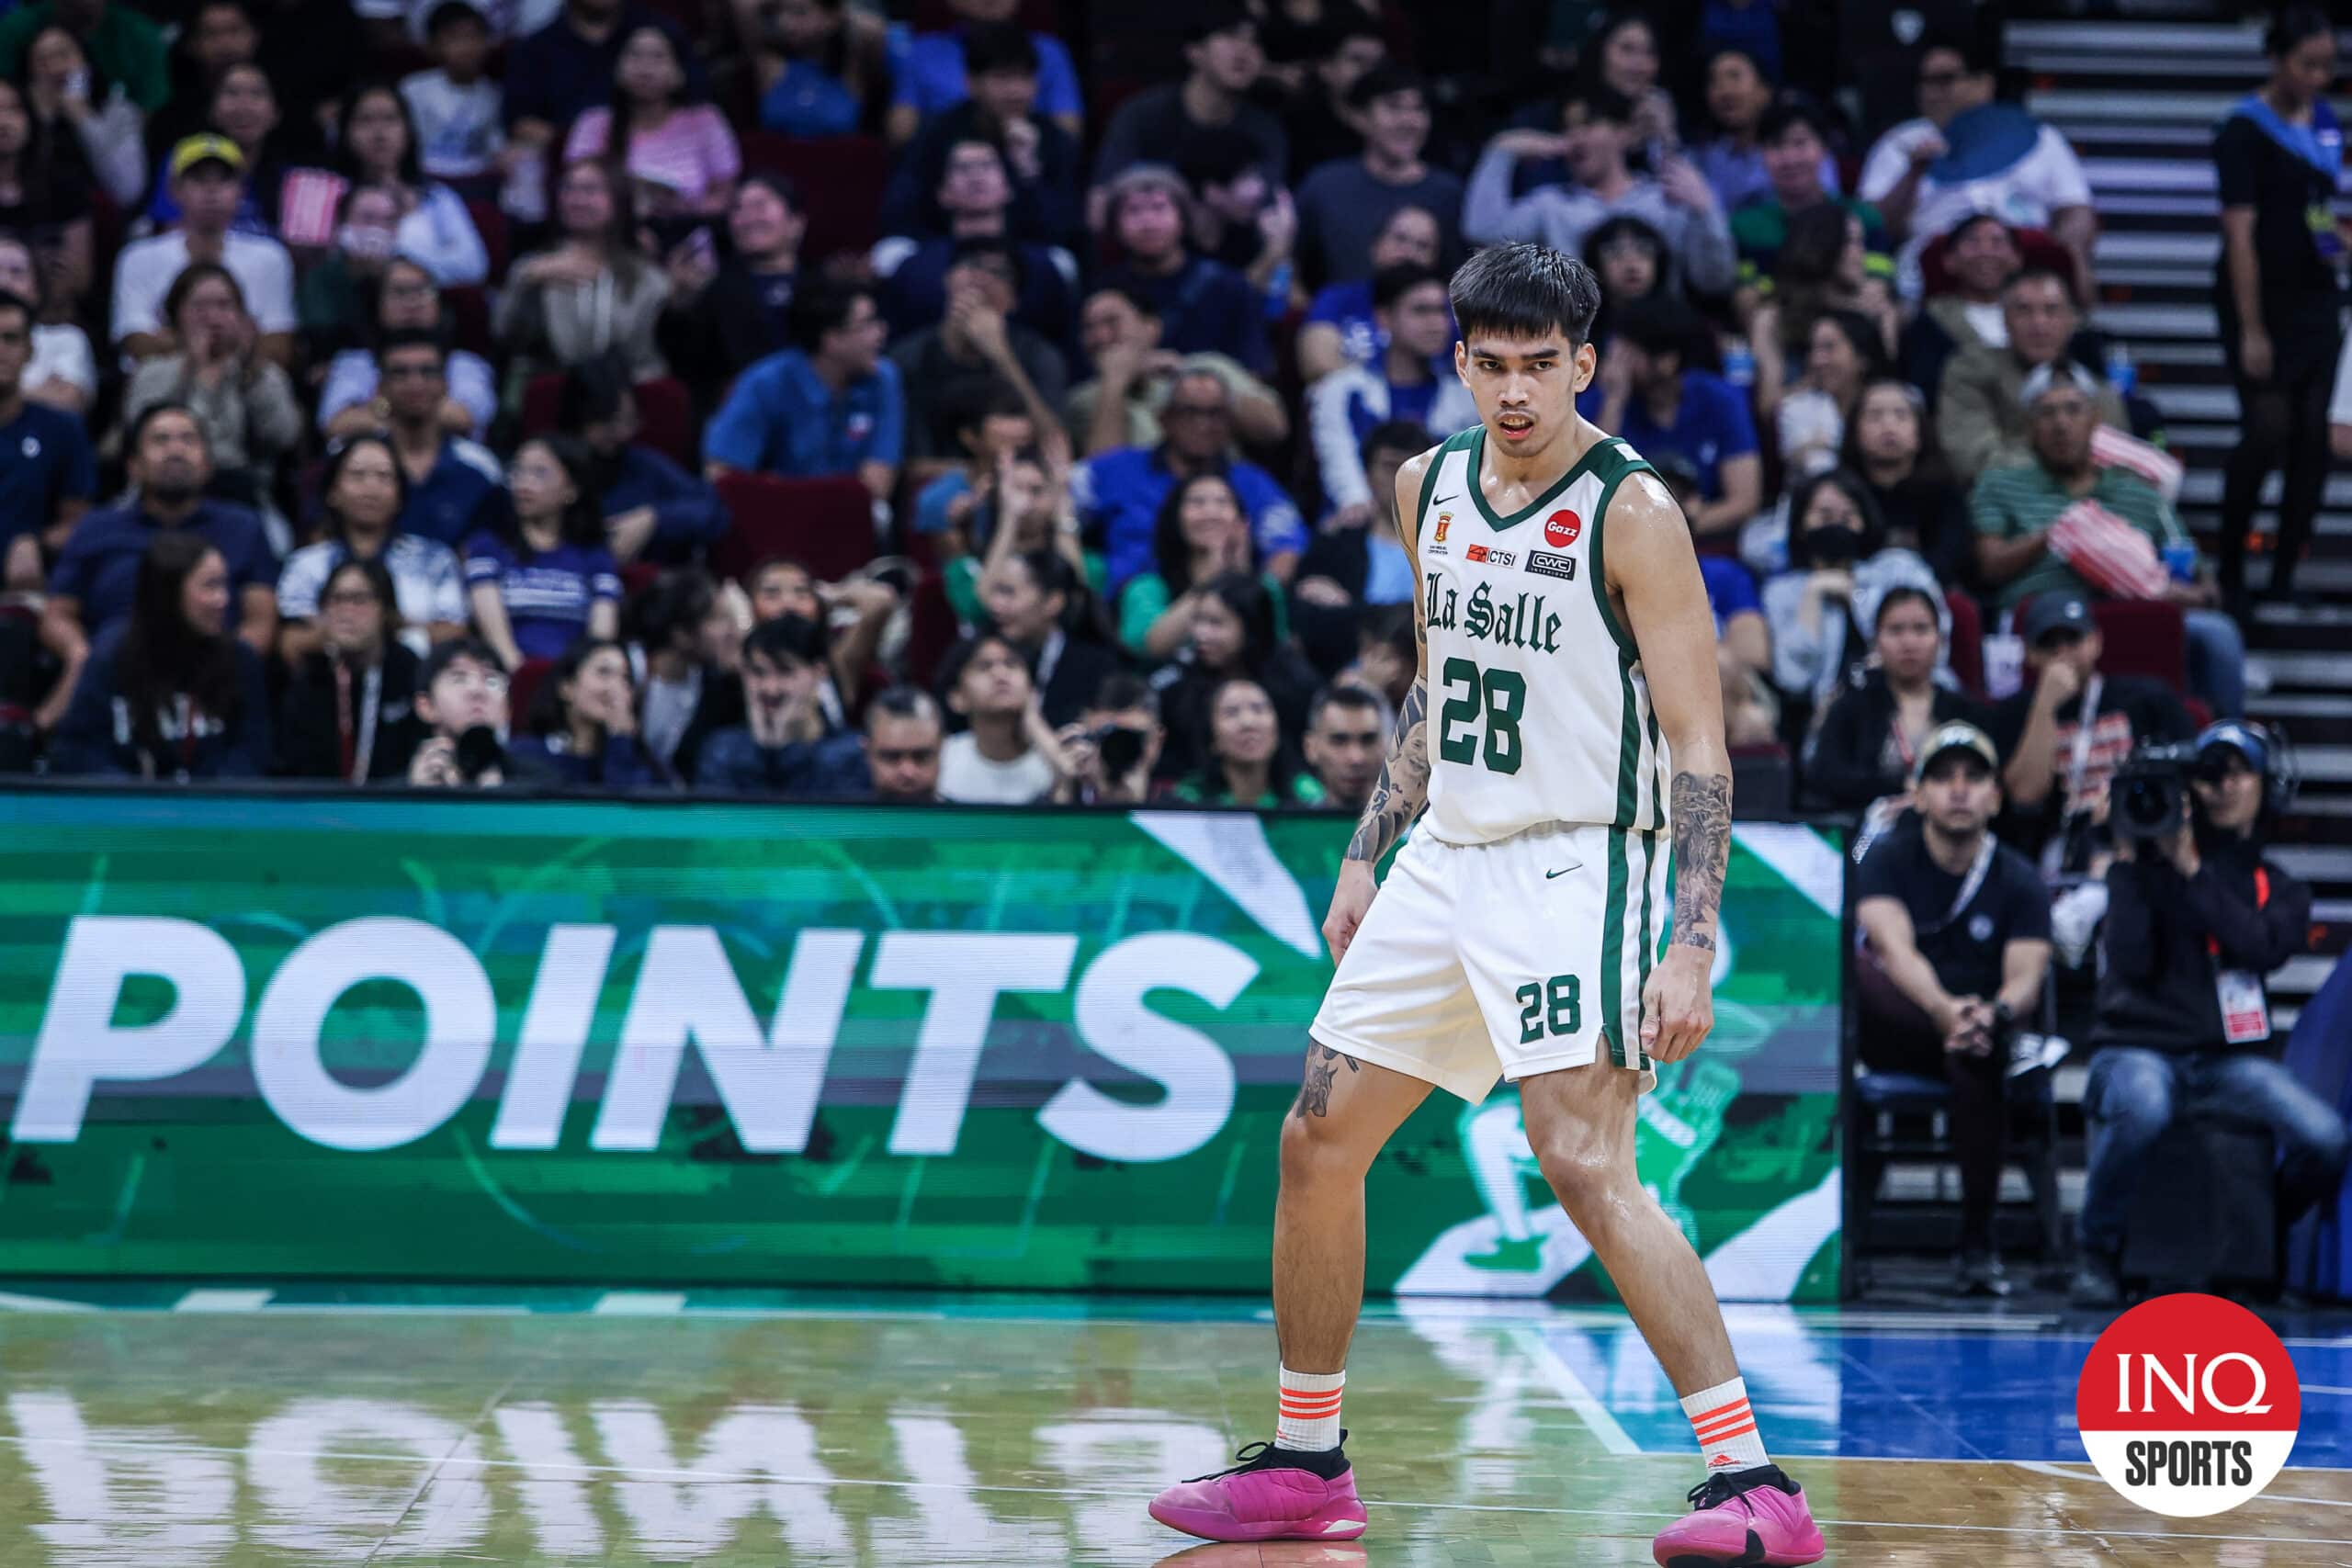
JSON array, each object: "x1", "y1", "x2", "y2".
[{"x1": 2075, "y1": 1295, "x2": 2302, "y2": 1518}]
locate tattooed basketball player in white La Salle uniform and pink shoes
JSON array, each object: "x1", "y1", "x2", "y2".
[{"x1": 1150, "y1": 244, "x2": 1823, "y2": 1568}]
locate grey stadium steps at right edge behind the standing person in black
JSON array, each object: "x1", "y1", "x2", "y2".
[{"x1": 2004, "y1": 21, "x2": 2352, "y2": 1025}]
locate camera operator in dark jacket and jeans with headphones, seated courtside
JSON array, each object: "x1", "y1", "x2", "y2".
[{"x1": 2072, "y1": 722, "x2": 2347, "y2": 1307}]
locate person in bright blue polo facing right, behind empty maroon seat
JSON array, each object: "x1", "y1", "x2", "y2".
[{"x1": 703, "y1": 285, "x2": 906, "y2": 501}]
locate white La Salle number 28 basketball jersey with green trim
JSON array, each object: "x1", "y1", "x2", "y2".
[{"x1": 1416, "y1": 425, "x2": 1668, "y2": 844}]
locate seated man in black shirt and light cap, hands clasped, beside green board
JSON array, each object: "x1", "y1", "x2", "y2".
[{"x1": 1853, "y1": 722, "x2": 2051, "y2": 1295}]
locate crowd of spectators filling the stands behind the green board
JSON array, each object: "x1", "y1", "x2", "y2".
[{"x1": 0, "y1": 0, "x2": 2277, "y2": 822}]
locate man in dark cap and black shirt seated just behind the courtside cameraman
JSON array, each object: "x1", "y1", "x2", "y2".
[{"x1": 1985, "y1": 592, "x2": 2197, "y2": 877}]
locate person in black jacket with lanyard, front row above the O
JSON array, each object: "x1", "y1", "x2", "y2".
[{"x1": 276, "y1": 559, "x2": 424, "y2": 785}]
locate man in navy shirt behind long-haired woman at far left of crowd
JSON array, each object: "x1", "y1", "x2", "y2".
[{"x1": 35, "y1": 402, "x2": 277, "y2": 728}]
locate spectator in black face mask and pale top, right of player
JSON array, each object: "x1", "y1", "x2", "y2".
[{"x1": 1764, "y1": 468, "x2": 1950, "y2": 705}]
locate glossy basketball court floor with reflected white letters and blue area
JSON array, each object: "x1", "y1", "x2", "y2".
[{"x1": 0, "y1": 1298, "x2": 2352, "y2": 1568}]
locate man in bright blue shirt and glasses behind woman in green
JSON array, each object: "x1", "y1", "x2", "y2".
[{"x1": 1070, "y1": 371, "x2": 1307, "y2": 597}]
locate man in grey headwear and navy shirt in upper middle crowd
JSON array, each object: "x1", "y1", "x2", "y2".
[{"x1": 1096, "y1": 164, "x2": 1272, "y2": 374}]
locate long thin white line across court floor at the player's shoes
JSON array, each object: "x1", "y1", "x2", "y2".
[{"x1": 18, "y1": 1437, "x2": 2352, "y2": 1547}]
